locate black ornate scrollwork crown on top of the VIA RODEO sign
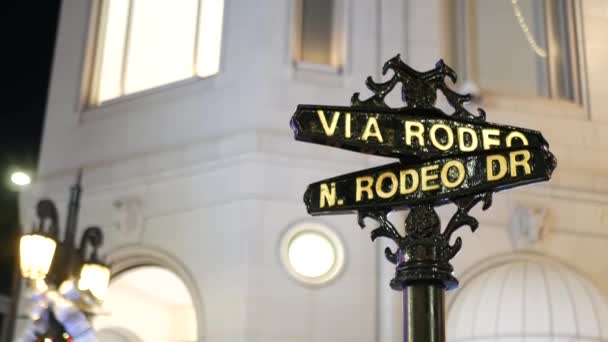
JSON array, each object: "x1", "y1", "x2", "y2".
[{"x1": 351, "y1": 55, "x2": 486, "y2": 121}]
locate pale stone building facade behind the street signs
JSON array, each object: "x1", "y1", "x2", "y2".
[{"x1": 18, "y1": 0, "x2": 608, "y2": 342}]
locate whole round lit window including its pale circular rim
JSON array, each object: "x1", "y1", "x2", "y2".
[{"x1": 281, "y1": 222, "x2": 344, "y2": 285}]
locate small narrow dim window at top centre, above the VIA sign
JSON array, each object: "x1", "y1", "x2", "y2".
[{"x1": 292, "y1": 0, "x2": 344, "y2": 69}]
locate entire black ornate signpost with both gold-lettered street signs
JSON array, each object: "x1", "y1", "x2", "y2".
[{"x1": 291, "y1": 55, "x2": 557, "y2": 342}]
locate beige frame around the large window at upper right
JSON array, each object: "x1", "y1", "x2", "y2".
[{"x1": 445, "y1": 0, "x2": 589, "y2": 118}]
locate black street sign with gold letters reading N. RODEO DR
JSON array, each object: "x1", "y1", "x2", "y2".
[{"x1": 304, "y1": 147, "x2": 555, "y2": 215}]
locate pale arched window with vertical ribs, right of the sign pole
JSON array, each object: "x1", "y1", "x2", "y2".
[{"x1": 447, "y1": 255, "x2": 608, "y2": 342}]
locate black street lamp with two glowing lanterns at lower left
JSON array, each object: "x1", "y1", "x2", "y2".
[{"x1": 20, "y1": 171, "x2": 110, "y2": 341}]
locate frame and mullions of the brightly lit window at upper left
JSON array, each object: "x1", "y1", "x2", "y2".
[{"x1": 77, "y1": 0, "x2": 224, "y2": 113}]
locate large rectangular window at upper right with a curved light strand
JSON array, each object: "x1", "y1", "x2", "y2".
[{"x1": 452, "y1": 0, "x2": 581, "y2": 103}]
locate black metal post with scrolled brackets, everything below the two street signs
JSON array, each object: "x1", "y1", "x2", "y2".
[{"x1": 366, "y1": 204, "x2": 470, "y2": 342}]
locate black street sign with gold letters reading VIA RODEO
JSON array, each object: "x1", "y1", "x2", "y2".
[{"x1": 291, "y1": 105, "x2": 547, "y2": 160}]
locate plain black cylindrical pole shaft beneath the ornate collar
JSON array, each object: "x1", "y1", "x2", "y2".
[{"x1": 403, "y1": 284, "x2": 446, "y2": 342}]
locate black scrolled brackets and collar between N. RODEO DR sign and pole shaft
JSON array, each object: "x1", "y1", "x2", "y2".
[{"x1": 358, "y1": 192, "x2": 492, "y2": 290}]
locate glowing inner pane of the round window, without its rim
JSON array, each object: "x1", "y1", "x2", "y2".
[{"x1": 287, "y1": 232, "x2": 336, "y2": 278}]
